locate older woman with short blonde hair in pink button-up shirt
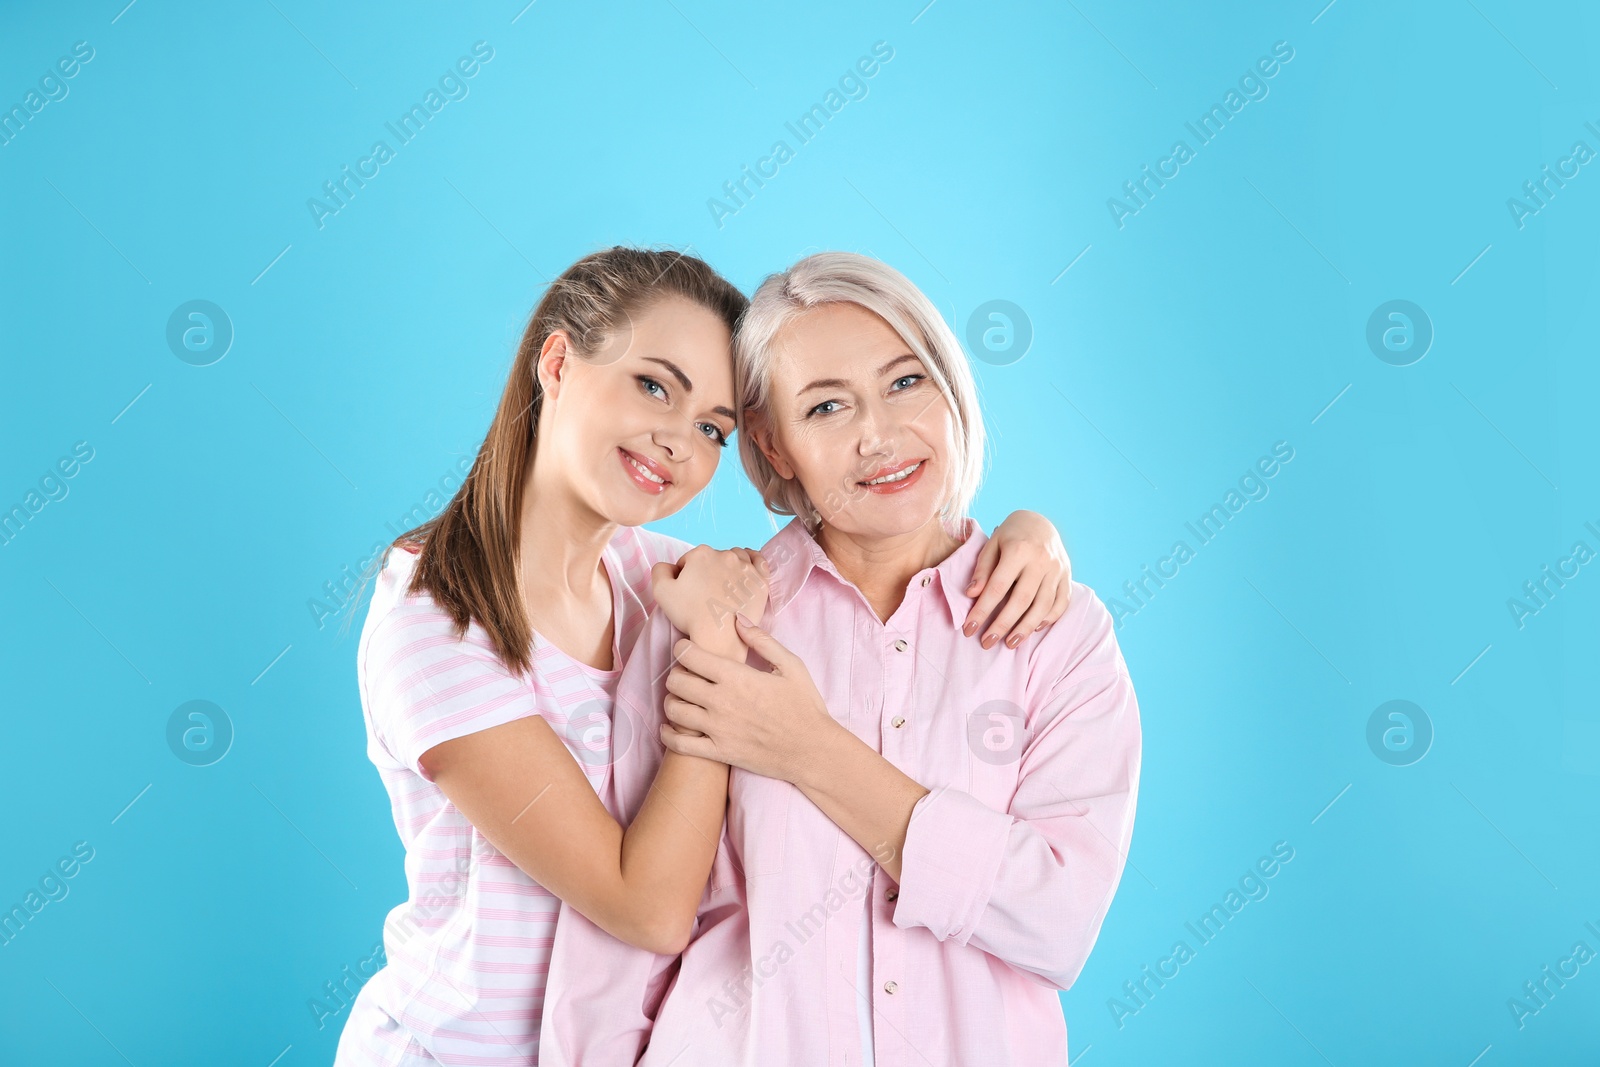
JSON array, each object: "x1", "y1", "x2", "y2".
[{"x1": 542, "y1": 253, "x2": 1139, "y2": 1067}]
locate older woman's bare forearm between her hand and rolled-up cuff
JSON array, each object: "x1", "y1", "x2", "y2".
[{"x1": 795, "y1": 720, "x2": 928, "y2": 881}]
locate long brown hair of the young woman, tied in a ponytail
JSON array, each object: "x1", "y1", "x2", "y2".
[{"x1": 384, "y1": 246, "x2": 749, "y2": 673}]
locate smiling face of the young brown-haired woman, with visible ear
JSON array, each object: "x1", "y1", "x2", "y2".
[{"x1": 538, "y1": 296, "x2": 734, "y2": 526}]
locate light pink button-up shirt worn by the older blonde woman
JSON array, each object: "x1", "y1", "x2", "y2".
[{"x1": 541, "y1": 518, "x2": 1139, "y2": 1067}]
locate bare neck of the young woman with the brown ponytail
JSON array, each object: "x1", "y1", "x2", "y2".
[{"x1": 517, "y1": 450, "x2": 618, "y2": 606}]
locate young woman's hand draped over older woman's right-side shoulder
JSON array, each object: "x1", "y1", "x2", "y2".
[{"x1": 962, "y1": 512, "x2": 1072, "y2": 648}]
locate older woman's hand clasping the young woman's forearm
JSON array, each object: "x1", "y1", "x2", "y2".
[{"x1": 661, "y1": 619, "x2": 840, "y2": 784}]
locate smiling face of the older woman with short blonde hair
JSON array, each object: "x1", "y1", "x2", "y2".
[{"x1": 752, "y1": 304, "x2": 955, "y2": 537}]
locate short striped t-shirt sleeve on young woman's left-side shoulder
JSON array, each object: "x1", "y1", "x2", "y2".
[{"x1": 363, "y1": 603, "x2": 538, "y2": 781}]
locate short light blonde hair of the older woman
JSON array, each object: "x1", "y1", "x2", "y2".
[{"x1": 733, "y1": 251, "x2": 984, "y2": 530}]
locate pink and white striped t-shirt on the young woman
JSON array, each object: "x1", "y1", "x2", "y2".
[{"x1": 334, "y1": 526, "x2": 690, "y2": 1067}]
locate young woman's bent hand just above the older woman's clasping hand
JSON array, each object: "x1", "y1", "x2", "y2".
[{"x1": 650, "y1": 544, "x2": 768, "y2": 654}]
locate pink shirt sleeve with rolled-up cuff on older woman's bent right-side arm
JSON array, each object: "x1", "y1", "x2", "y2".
[{"x1": 894, "y1": 593, "x2": 1141, "y2": 990}]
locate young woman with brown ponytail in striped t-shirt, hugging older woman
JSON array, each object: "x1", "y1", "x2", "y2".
[{"x1": 336, "y1": 248, "x2": 1067, "y2": 1067}]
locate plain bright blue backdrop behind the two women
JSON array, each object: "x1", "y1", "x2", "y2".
[{"x1": 0, "y1": 0, "x2": 1600, "y2": 1067}]
